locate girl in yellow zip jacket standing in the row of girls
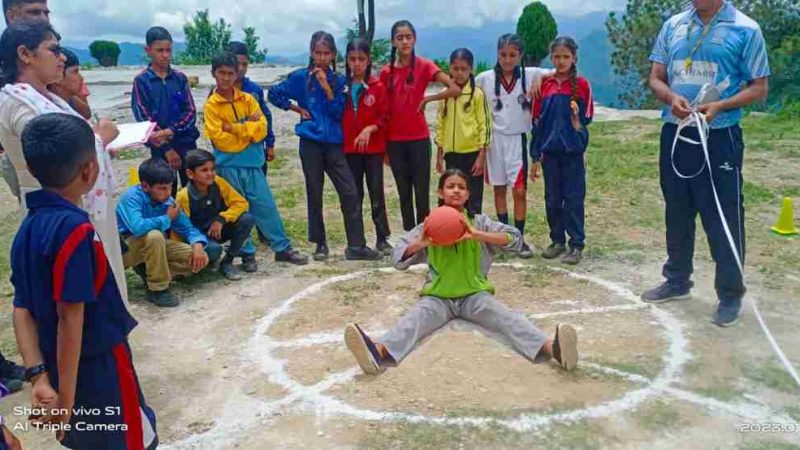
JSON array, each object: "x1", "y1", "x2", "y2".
[{"x1": 436, "y1": 48, "x2": 492, "y2": 216}]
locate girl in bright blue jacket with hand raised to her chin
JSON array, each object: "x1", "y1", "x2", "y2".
[{"x1": 269, "y1": 31, "x2": 382, "y2": 261}]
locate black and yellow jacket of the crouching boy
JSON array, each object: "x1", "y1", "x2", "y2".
[{"x1": 175, "y1": 177, "x2": 250, "y2": 231}]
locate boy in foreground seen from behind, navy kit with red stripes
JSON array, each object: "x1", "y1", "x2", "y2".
[{"x1": 11, "y1": 114, "x2": 158, "y2": 450}]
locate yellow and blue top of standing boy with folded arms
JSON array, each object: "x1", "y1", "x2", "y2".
[{"x1": 204, "y1": 88, "x2": 267, "y2": 168}]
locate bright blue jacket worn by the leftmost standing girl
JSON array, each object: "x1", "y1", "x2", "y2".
[{"x1": 267, "y1": 68, "x2": 346, "y2": 144}]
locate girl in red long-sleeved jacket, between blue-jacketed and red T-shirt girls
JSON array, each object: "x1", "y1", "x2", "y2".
[{"x1": 342, "y1": 38, "x2": 393, "y2": 255}]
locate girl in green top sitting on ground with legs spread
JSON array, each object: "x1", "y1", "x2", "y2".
[{"x1": 344, "y1": 169, "x2": 578, "y2": 374}]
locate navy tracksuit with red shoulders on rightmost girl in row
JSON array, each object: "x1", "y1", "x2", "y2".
[{"x1": 531, "y1": 77, "x2": 594, "y2": 249}]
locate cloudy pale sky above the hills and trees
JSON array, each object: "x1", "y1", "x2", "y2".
[{"x1": 49, "y1": 0, "x2": 625, "y2": 53}]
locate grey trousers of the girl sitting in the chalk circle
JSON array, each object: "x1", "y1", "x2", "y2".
[{"x1": 378, "y1": 292, "x2": 549, "y2": 363}]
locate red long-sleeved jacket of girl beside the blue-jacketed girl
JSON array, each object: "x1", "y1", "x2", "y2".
[{"x1": 342, "y1": 77, "x2": 389, "y2": 155}]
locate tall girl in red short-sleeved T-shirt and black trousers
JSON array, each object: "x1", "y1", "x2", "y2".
[{"x1": 380, "y1": 20, "x2": 461, "y2": 231}]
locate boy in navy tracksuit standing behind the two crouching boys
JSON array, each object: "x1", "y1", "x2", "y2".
[{"x1": 131, "y1": 27, "x2": 200, "y2": 197}]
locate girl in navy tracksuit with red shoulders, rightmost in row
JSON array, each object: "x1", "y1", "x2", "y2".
[{"x1": 531, "y1": 37, "x2": 594, "y2": 264}]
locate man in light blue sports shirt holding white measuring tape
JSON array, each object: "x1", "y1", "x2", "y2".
[{"x1": 642, "y1": 0, "x2": 770, "y2": 327}]
